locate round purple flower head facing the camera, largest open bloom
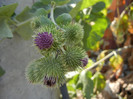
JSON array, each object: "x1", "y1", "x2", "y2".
[{"x1": 34, "y1": 32, "x2": 53, "y2": 50}]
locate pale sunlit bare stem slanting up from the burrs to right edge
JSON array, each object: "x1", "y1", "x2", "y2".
[{"x1": 85, "y1": 45, "x2": 133, "y2": 71}]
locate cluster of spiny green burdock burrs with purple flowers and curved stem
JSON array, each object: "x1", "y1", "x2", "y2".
[{"x1": 26, "y1": 0, "x2": 88, "y2": 87}]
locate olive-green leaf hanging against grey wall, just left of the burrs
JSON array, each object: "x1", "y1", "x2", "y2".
[{"x1": 15, "y1": 20, "x2": 33, "y2": 40}]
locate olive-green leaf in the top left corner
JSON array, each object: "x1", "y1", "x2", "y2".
[{"x1": 0, "y1": 3, "x2": 18, "y2": 17}]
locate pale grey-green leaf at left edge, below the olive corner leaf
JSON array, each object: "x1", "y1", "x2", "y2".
[{"x1": 0, "y1": 17, "x2": 13, "y2": 38}]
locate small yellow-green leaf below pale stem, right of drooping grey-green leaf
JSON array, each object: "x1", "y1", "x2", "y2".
[{"x1": 93, "y1": 72, "x2": 105, "y2": 91}]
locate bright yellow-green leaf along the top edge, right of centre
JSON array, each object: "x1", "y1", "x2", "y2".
[{"x1": 70, "y1": 0, "x2": 112, "y2": 18}]
